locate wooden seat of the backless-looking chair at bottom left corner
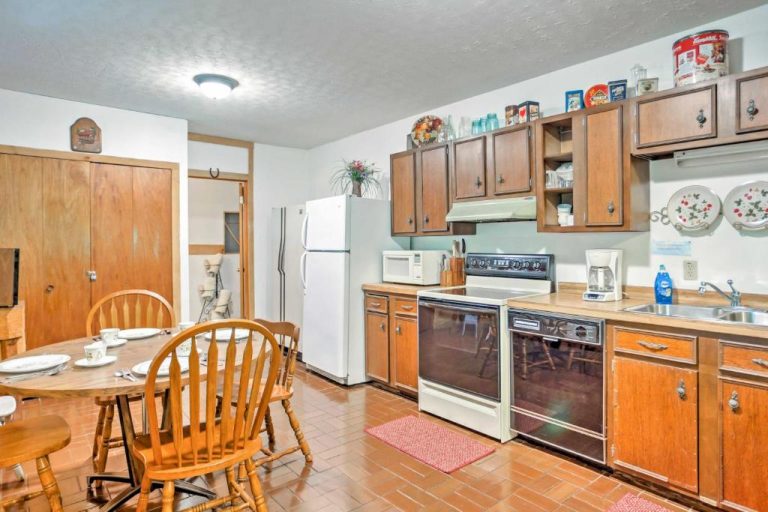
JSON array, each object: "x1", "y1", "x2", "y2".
[{"x1": 0, "y1": 415, "x2": 71, "y2": 467}]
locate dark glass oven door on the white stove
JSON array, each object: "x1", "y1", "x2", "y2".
[{"x1": 419, "y1": 299, "x2": 501, "y2": 402}]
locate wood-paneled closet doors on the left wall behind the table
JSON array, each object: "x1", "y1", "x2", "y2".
[{"x1": 0, "y1": 147, "x2": 178, "y2": 348}]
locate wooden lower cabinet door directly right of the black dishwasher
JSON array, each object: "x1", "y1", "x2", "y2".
[{"x1": 612, "y1": 357, "x2": 698, "y2": 493}]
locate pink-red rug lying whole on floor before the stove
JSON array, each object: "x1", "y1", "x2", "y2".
[{"x1": 365, "y1": 416, "x2": 495, "y2": 473}]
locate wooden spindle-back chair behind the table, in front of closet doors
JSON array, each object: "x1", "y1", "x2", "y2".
[{"x1": 85, "y1": 290, "x2": 176, "y2": 480}]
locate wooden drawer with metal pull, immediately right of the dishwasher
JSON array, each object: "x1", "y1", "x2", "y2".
[{"x1": 614, "y1": 327, "x2": 696, "y2": 363}]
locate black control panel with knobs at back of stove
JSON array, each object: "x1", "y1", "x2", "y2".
[{"x1": 464, "y1": 253, "x2": 555, "y2": 282}]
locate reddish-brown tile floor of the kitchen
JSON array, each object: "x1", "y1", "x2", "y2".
[{"x1": 0, "y1": 370, "x2": 700, "y2": 512}]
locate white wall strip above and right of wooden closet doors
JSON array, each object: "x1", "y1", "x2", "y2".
[{"x1": 0, "y1": 89, "x2": 189, "y2": 315}]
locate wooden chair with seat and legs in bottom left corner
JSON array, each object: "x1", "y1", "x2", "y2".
[{"x1": 0, "y1": 416, "x2": 70, "y2": 512}]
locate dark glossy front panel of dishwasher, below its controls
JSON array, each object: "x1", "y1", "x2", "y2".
[{"x1": 511, "y1": 332, "x2": 603, "y2": 434}]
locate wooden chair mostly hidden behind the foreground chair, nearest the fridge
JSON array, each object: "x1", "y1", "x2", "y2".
[{"x1": 219, "y1": 319, "x2": 312, "y2": 466}]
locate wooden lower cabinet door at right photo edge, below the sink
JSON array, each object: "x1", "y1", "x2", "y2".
[{"x1": 720, "y1": 380, "x2": 768, "y2": 510}]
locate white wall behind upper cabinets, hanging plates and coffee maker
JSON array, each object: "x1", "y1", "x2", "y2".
[{"x1": 309, "y1": 5, "x2": 768, "y2": 293}]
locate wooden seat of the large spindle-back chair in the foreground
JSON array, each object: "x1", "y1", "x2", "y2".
[{"x1": 133, "y1": 421, "x2": 262, "y2": 481}]
